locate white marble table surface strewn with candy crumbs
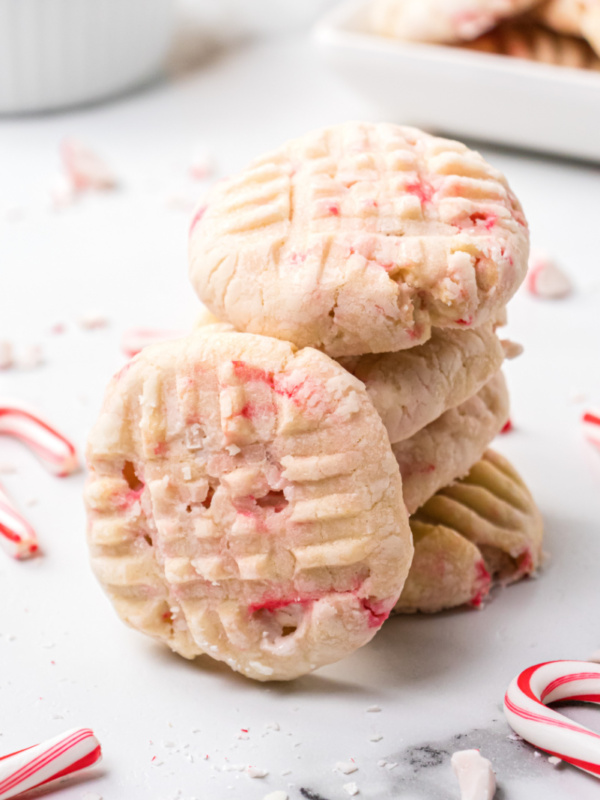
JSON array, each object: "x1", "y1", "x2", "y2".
[{"x1": 0, "y1": 29, "x2": 600, "y2": 800}]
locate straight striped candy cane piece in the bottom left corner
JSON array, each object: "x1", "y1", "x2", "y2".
[{"x1": 0, "y1": 728, "x2": 102, "y2": 800}]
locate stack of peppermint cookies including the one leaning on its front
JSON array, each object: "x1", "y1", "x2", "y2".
[{"x1": 86, "y1": 123, "x2": 542, "y2": 680}]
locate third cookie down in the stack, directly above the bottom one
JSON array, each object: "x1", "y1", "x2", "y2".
[{"x1": 392, "y1": 372, "x2": 509, "y2": 514}]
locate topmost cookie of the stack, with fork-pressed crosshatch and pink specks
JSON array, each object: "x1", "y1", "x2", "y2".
[{"x1": 189, "y1": 123, "x2": 529, "y2": 356}]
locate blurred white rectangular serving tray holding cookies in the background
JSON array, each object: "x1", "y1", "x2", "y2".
[{"x1": 314, "y1": 0, "x2": 600, "y2": 161}]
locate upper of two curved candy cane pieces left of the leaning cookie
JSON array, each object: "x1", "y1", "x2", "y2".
[{"x1": 0, "y1": 400, "x2": 79, "y2": 478}]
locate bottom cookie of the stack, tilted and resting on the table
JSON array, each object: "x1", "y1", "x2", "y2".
[{"x1": 394, "y1": 450, "x2": 543, "y2": 614}]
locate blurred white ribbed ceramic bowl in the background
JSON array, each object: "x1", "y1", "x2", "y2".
[{"x1": 0, "y1": 0, "x2": 175, "y2": 113}]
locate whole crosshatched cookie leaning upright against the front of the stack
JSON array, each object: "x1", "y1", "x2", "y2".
[{"x1": 86, "y1": 329, "x2": 412, "y2": 680}]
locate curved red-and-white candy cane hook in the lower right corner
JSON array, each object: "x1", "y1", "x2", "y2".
[{"x1": 504, "y1": 661, "x2": 600, "y2": 777}]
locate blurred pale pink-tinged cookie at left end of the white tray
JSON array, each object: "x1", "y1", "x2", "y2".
[{"x1": 369, "y1": 0, "x2": 539, "y2": 44}]
